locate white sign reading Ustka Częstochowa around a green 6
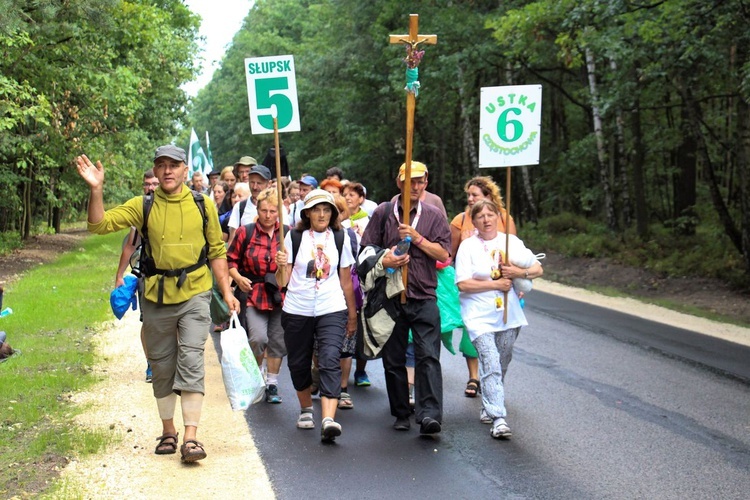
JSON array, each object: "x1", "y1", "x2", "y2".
[{"x1": 479, "y1": 85, "x2": 542, "y2": 168}]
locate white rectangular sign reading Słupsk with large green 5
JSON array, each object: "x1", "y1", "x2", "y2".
[{"x1": 245, "y1": 56, "x2": 300, "y2": 135}]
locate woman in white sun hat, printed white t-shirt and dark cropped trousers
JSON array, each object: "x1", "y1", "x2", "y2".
[{"x1": 276, "y1": 189, "x2": 357, "y2": 442}]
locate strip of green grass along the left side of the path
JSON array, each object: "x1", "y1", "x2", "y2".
[{"x1": 0, "y1": 229, "x2": 128, "y2": 498}]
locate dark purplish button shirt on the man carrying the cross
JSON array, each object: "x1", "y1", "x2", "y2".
[{"x1": 361, "y1": 198, "x2": 451, "y2": 300}]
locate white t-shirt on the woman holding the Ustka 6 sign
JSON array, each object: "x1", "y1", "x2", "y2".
[{"x1": 456, "y1": 233, "x2": 534, "y2": 341}]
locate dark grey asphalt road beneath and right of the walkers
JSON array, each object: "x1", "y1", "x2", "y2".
[{"x1": 245, "y1": 292, "x2": 750, "y2": 499}]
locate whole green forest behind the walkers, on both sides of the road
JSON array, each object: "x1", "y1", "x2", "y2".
[{"x1": 0, "y1": 0, "x2": 750, "y2": 278}]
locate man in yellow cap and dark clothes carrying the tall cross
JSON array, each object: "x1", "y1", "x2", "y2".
[{"x1": 361, "y1": 162, "x2": 451, "y2": 434}]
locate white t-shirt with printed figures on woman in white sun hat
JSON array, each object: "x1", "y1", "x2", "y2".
[{"x1": 283, "y1": 229, "x2": 355, "y2": 317}]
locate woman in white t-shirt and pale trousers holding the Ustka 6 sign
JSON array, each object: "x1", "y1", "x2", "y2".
[{"x1": 456, "y1": 199, "x2": 544, "y2": 439}]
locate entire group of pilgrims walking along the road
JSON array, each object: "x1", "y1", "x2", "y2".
[{"x1": 75, "y1": 145, "x2": 543, "y2": 462}]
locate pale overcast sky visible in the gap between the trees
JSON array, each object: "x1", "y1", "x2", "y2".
[{"x1": 182, "y1": 0, "x2": 253, "y2": 96}]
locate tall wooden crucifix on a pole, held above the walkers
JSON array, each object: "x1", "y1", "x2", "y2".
[{"x1": 390, "y1": 14, "x2": 437, "y2": 303}]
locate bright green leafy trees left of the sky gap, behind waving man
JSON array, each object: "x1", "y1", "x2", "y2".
[{"x1": 0, "y1": 0, "x2": 203, "y2": 238}]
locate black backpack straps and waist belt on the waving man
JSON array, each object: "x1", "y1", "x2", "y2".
[{"x1": 130, "y1": 190, "x2": 208, "y2": 305}]
